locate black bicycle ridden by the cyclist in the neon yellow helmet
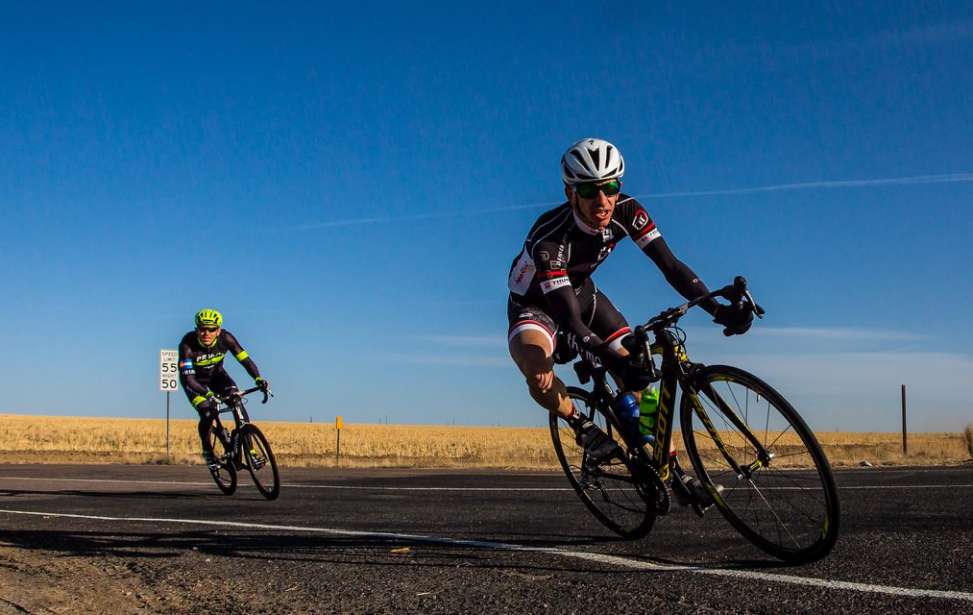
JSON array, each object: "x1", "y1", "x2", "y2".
[{"x1": 210, "y1": 387, "x2": 280, "y2": 500}]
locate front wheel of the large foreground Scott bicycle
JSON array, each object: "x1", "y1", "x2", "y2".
[{"x1": 680, "y1": 365, "x2": 840, "y2": 564}]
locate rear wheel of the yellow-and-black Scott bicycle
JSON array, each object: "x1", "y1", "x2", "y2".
[{"x1": 550, "y1": 387, "x2": 656, "y2": 539}]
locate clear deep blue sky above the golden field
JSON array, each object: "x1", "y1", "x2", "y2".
[{"x1": 0, "y1": 2, "x2": 973, "y2": 431}]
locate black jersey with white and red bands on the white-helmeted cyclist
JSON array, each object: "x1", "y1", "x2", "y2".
[{"x1": 507, "y1": 194, "x2": 718, "y2": 349}]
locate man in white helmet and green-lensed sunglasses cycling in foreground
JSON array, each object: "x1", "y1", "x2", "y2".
[{"x1": 507, "y1": 138, "x2": 753, "y2": 507}]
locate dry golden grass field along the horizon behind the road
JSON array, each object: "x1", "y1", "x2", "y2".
[{"x1": 0, "y1": 415, "x2": 973, "y2": 469}]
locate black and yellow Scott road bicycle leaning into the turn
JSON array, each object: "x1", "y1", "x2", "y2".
[{"x1": 550, "y1": 277, "x2": 839, "y2": 563}]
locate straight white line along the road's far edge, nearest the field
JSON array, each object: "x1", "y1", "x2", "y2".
[{"x1": 0, "y1": 476, "x2": 973, "y2": 492}]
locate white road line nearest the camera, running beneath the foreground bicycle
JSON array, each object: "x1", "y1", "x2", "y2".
[{"x1": 0, "y1": 509, "x2": 973, "y2": 602}]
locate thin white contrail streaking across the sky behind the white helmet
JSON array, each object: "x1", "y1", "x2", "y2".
[{"x1": 292, "y1": 173, "x2": 973, "y2": 231}]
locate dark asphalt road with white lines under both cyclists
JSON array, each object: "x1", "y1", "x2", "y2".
[{"x1": 0, "y1": 465, "x2": 973, "y2": 613}]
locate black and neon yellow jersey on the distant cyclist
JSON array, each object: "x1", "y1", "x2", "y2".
[{"x1": 179, "y1": 329, "x2": 260, "y2": 406}]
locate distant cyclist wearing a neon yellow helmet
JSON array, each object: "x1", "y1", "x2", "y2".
[{"x1": 179, "y1": 308, "x2": 270, "y2": 469}]
